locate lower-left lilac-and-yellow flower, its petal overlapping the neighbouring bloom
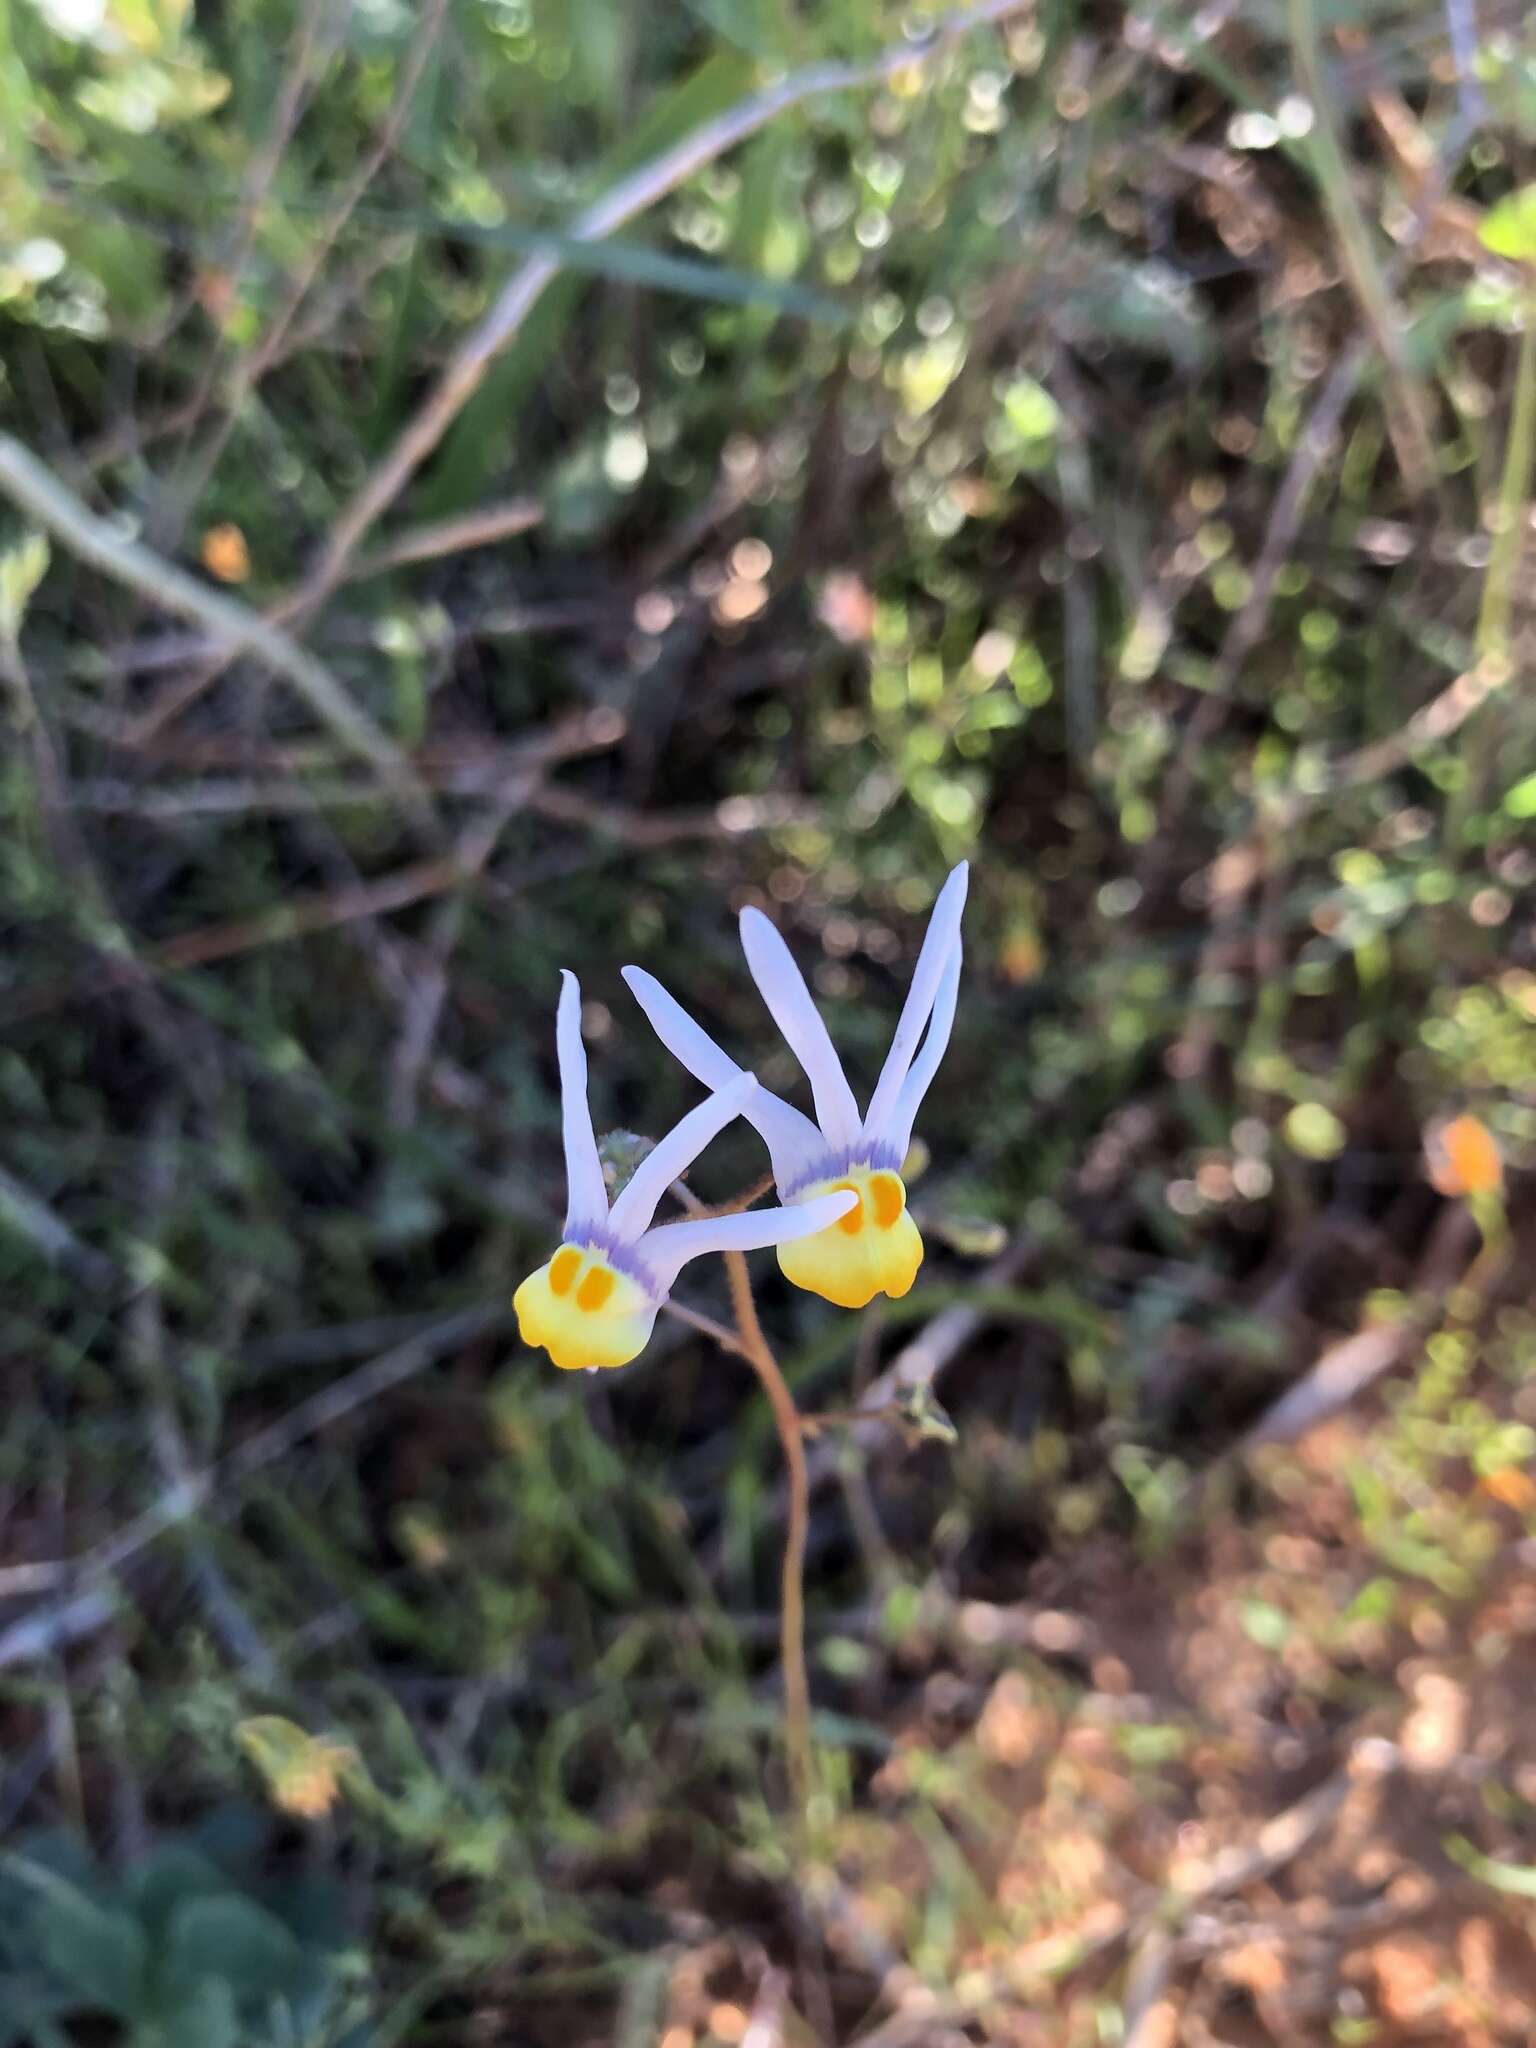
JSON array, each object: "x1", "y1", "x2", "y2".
[{"x1": 512, "y1": 973, "x2": 854, "y2": 1370}]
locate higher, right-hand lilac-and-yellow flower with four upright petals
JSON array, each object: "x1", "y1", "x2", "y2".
[{"x1": 625, "y1": 862, "x2": 969, "y2": 1309}]
